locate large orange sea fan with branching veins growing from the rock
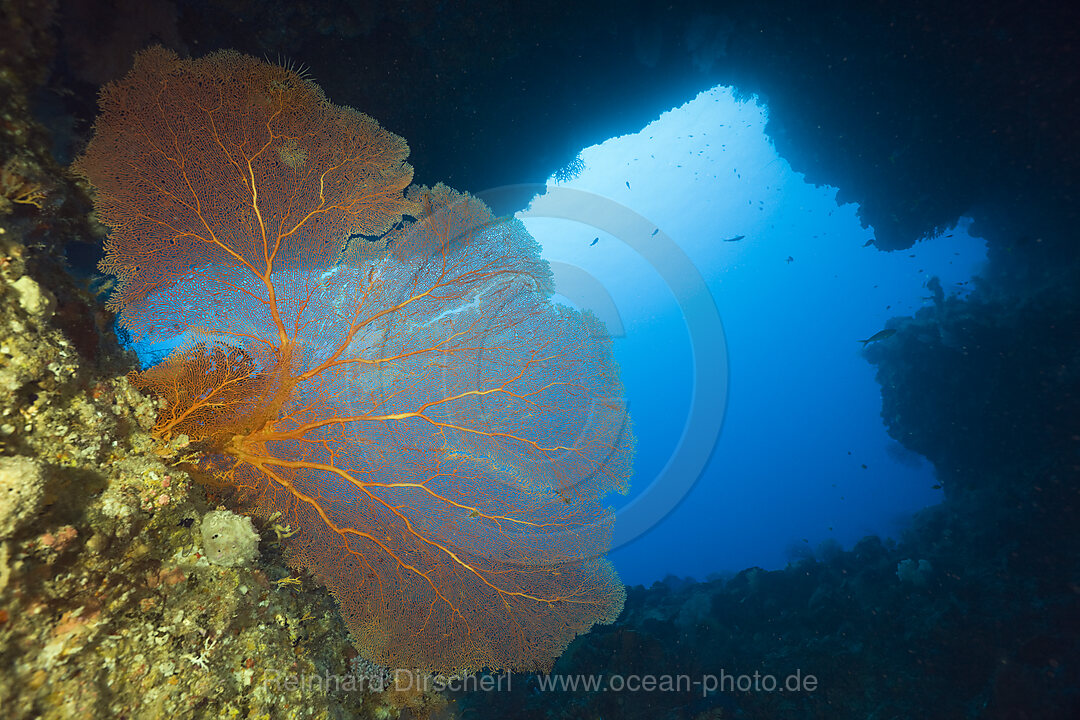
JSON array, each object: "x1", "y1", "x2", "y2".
[{"x1": 77, "y1": 49, "x2": 633, "y2": 671}]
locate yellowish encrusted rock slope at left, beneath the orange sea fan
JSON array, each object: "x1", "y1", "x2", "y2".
[{"x1": 0, "y1": 14, "x2": 444, "y2": 720}]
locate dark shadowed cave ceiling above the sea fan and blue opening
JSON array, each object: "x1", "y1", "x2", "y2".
[{"x1": 56, "y1": 0, "x2": 1080, "y2": 259}]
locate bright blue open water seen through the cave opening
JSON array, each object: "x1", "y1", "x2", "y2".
[{"x1": 522, "y1": 87, "x2": 985, "y2": 584}]
